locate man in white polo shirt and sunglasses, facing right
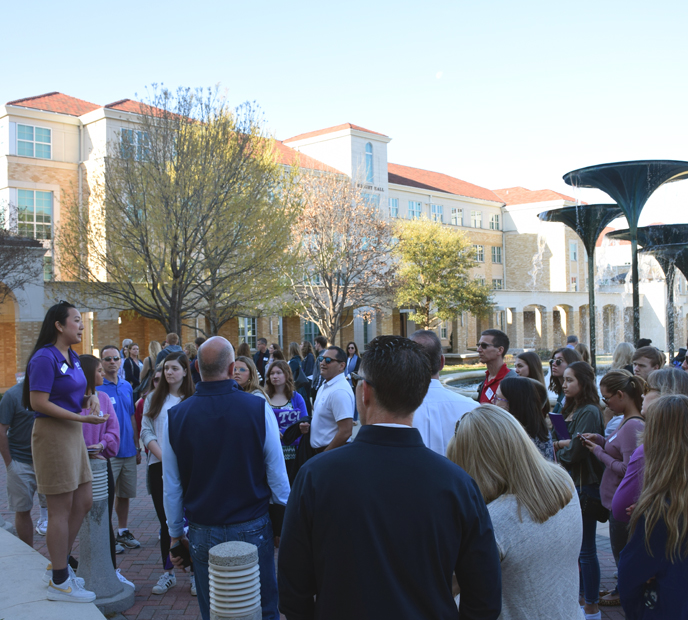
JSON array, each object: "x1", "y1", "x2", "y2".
[{"x1": 300, "y1": 346, "x2": 354, "y2": 452}]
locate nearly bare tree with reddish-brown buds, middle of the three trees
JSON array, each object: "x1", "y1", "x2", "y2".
[{"x1": 288, "y1": 172, "x2": 394, "y2": 342}]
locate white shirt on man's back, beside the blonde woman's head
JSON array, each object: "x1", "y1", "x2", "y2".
[{"x1": 413, "y1": 379, "x2": 478, "y2": 456}]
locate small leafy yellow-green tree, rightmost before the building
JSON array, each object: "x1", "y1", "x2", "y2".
[{"x1": 393, "y1": 219, "x2": 492, "y2": 329}]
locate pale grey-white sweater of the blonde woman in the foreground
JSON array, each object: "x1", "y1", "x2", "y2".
[{"x1": 487, "y1": 489, "x2": 585, "y2": 620}]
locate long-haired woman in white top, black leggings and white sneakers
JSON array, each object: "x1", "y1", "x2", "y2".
[{"x1": 141, "y1": 351, "x2": 196, "y2": 594}]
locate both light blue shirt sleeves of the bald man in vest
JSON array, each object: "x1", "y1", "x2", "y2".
[{"x1": 158, "y1": 402, "x2": 289, "y2": 538}]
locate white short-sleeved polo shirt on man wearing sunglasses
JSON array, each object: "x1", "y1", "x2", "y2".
[{"x1": 311, "y1": 372, "x2": 355, "y2": 448}]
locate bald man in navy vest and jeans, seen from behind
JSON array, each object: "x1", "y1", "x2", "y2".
[{"x1": 161, "y1": 336, "x2": 289, "y2": 620}]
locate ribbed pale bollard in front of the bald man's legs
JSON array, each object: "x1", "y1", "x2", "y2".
[{"x1": 208, "y1": 541, "x2": 262, "y2": 620}]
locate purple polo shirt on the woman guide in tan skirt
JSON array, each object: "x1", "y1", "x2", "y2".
[{"x1": 26, "y1": 344, "x2": 87, "y2": 418}]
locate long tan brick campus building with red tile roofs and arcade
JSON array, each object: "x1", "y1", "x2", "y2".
[{"x1": 0, "y1": 93, "x2": 688, "y2": 388}]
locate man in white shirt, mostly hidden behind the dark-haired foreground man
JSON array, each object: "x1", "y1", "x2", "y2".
[{"x1": 411, "y1": 329, "x2": 478, "y2": 456}]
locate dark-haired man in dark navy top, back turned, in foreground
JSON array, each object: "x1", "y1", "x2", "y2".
[{"x1": 279, "y1": 336, "x2": 502, "y2": 620}]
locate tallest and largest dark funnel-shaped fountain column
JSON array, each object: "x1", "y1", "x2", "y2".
[{"x1": 564, "y1": 160, "x2": 688, "y2": 342}]
